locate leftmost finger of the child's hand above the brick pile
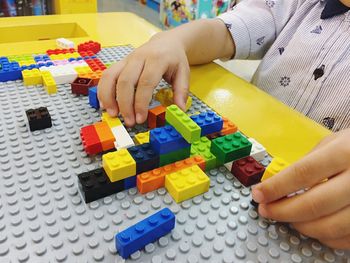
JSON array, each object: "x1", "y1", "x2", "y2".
[{"x1": 97, "y1": 60, "x2": 125, "y2": 116}]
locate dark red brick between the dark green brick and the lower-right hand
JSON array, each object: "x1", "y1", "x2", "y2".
[{"x1": 231, "y1": 156, "x2": 265, "y2": 187}]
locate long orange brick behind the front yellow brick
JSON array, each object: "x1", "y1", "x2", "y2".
[{"x1": 137, "y1": 156, "x2": 205, "y2": 194}]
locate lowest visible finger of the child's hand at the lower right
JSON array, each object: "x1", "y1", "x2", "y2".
[{"x1": 293, "y1": 206, "x2": 350, "y2": 240}]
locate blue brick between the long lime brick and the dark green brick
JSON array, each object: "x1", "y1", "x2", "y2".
[{"x1": 191, "y1": 111, "x2": 224, "y2": 136}]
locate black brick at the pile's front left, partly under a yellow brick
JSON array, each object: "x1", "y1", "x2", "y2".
[{"x1": 78, "y1": 168, "x2": 124, "y2": 203}]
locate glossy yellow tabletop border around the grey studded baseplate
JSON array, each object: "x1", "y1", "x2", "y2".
[{"x1": 0, "y1": 13, "x2": 330, "y2": 165}]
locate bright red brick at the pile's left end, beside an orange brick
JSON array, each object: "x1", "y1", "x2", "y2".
[{"x1": 80, "y1": 125, "x2": 103, "y2": 154}]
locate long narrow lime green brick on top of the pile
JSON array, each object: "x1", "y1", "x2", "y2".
[{"x1": 165, "y1": 105, "x2": 201, "y2": 143}]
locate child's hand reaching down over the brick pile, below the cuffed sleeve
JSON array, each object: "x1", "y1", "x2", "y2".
[{"x1": 98, "y1": 32, "x2": 190, "y2": 126}]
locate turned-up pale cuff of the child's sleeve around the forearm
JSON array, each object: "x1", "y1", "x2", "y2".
[{"x1": 217, "y1": 11, "x2": 251, "y2": 59}]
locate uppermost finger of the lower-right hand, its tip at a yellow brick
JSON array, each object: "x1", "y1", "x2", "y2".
[{"x1": 253, "y1": 140, "x2": 350, "y2": 203}]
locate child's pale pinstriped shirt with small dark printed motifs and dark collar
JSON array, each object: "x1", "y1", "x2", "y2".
[{"x1": 219, "y1": 0, "x2": 350, "y2": 131}]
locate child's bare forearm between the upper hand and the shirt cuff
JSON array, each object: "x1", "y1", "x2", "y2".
[{"x1": 155, "y1": 19, "x2": 235, "y2": 65}]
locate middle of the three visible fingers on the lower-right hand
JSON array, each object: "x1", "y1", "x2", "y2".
[{"x1": 259, "y1": 171, "x2": 350, "y2": 223}]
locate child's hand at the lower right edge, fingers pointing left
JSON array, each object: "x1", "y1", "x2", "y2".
[{"x1": 253, "y1": 129, "x2": 350, "y2": 249}]
